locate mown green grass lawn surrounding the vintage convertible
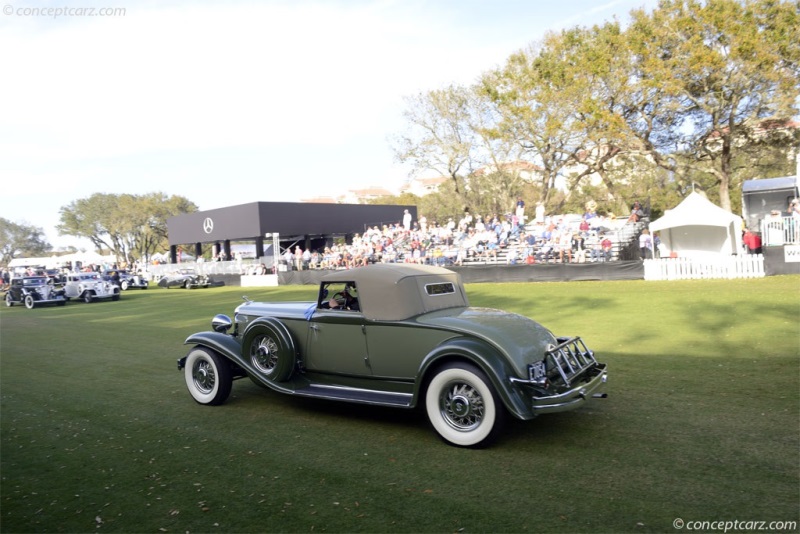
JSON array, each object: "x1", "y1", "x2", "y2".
[{"x1": 0, "y1": 276, "x2": 800, "y2": 533}]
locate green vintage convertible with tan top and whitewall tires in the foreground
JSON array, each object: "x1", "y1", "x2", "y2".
[{"x1": 178, "y1": 264, "x2": 606, "y2": 447}]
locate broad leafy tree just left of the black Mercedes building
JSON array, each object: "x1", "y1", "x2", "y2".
[{"x1": 57, "y1": 193, "x2": 197, "y2": 263}]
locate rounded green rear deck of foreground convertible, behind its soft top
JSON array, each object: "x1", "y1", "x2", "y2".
[{"x1": 417, "y1": 307, "x2": 558, "y2": 372}]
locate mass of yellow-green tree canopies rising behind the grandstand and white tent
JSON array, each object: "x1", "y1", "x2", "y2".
[{"x1": 395, "y1": 0, "x2": 800, "y2": 218}]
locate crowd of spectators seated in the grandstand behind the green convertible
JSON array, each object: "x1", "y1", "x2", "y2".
[{"x1": 260, "y1": 204, "x2": 640, "y2": 274}]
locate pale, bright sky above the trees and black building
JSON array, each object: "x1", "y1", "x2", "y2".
[{"x1": 0, "y1": 0, "x2": 657, "y2": 248}]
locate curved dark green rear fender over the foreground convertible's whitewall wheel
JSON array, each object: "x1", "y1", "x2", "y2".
[{"x1": 413, "y1": 338, "x2": 530, "y2": 419}]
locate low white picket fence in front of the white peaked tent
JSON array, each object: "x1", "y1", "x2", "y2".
[{"x1": 644, "y1": 254, "x2": 764, "y2": 280}]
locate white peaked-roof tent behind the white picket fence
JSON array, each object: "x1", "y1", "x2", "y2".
[{"x1": 650, "y1": 192, "x2": 742, "y2": 257}]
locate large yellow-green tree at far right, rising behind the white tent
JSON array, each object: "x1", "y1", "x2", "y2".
[{"x1": 623, "y1": 0, "x2": 800, "y2": 210}]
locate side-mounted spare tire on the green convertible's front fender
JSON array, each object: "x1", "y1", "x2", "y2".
[{"x1": 242, "y1": 319, "x2": 297, "y2": 382}]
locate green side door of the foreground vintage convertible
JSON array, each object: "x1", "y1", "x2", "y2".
[{"x1": 305, "y1": 308, "x2": 372, "y2": 376}]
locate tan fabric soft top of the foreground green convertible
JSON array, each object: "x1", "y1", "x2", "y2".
[{"x1": 322, "y1": 263, "x2": 469, "y2": 321}]
